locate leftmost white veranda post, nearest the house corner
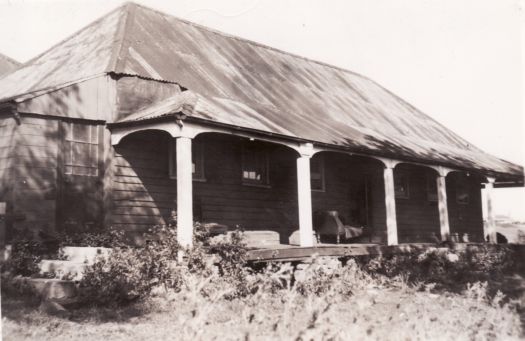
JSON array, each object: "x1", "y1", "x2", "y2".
[{"x1": 176, "y1": 137, "x2": 193, "y2": 247}]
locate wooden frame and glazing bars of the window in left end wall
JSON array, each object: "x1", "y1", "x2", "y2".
[{"x1": 62, "y1": 121, "x2": 102, "y2": 177}]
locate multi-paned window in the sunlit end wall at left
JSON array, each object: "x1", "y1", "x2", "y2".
[{"x1": 64, "y1": 123, "x2": 99, "y2": 176}]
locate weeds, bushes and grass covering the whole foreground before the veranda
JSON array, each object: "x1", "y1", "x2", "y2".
[{"x1": 2, "y1": 228, "x2": 522, "y2": 340}]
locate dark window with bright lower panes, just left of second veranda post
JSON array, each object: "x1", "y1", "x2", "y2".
[{"x1": 242, "y1": 142, "x2": 270, "y2": 185}]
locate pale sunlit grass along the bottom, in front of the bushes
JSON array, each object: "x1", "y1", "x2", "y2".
[{"x1": 2, "y1": 260, "x2": 523, "y2": 341}]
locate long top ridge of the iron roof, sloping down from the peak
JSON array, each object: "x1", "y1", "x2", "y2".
[{"x1": 126, "y1": 1, "x2": 371, "y2": 80}]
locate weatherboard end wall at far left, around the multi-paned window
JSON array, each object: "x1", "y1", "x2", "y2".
[{"x1": 0, "y1": 114, "x2": 108, "y2": 239}]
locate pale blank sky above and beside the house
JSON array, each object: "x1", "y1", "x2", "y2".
[{"x1": 0, "y1": 0, "x2": 525, "y2": 221}]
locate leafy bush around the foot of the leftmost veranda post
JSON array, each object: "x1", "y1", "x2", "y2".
[{"x1": 80, "y1": 224, "x2": 249, "y2": 305}]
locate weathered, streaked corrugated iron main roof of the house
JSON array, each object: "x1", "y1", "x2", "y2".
[{"x1": 0, "y1": 4, "x2": 523, "y2": 176}]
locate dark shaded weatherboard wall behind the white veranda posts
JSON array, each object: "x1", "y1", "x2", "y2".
[{"x1": 109, "y1": 128, "x2": 482, "y2": 243}]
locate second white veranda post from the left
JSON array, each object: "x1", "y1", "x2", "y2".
[{"x1": 297, "y1": 144, "x2": 314, "y2": 247}]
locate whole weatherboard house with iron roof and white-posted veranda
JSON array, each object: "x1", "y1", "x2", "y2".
[{"x1": 0, "y1": 3, "x2": 523, "y2": 247}]
